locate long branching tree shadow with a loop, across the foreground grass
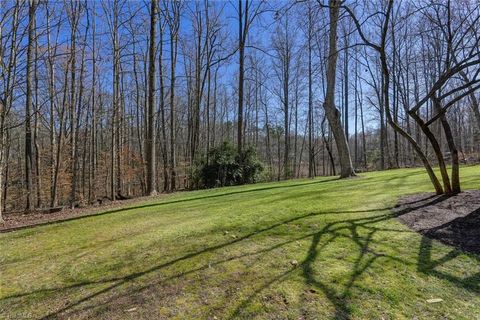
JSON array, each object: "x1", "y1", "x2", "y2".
[{"x1": 2, "y1": 196, "x2": 464, "y2": 319}]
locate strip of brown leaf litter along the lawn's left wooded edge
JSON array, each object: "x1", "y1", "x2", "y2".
[{"x1": 0, "y1": 194, "x2": 176, "y2": 232}]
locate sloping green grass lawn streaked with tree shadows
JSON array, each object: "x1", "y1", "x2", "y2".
[{"x1": 0, "y1": 166, "x2": 480, "y2": 319}]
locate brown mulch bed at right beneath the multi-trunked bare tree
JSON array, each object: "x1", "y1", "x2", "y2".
[{"x1": 394, "y1": 190, "x2": 480, "y2": 254}]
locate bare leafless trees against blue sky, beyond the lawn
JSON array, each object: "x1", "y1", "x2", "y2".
[{"x1": 0, "y1": 0, "x2": 480, "y2": 219}]
